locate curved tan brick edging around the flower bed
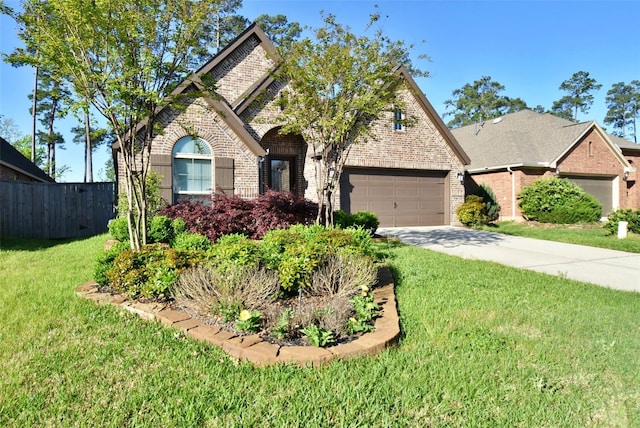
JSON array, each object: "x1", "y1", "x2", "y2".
[{"x1": 75, "y1": 267, "x2": 400, "y2": 366}]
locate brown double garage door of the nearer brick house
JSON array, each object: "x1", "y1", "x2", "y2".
[{"x1": 340, "y1": 168, "x2": 448, "y2": 227}]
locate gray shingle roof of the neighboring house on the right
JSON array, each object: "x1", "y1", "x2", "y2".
[{"x1": 451, "y1": 110, "x2": 633, "y2": 171}]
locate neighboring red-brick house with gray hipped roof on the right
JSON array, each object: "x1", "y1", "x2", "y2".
[{"x1": 452, "y1": 110, "x2": 640, "y2": 219}]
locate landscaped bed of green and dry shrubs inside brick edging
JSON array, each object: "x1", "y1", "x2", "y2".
[{"x1": 95, "y1": 221, "x2": 379, "y2": 347}]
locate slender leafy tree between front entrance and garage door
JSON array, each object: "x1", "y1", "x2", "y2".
[{"x1": 276, "y1": 10, "x2": 424, "y2": 225}]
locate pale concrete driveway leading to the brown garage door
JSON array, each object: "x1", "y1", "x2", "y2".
[{"x1": 377, "y1": 226, "x2": 640, "y2": 292}]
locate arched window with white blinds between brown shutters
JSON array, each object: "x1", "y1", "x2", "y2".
[{"x1": 172, "y1": 137, "x2": 213, "y2": 202}]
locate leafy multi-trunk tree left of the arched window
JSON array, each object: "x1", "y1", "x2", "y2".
[{"x1": 12, "y1": 0, "x2": 225, "y2": 250}]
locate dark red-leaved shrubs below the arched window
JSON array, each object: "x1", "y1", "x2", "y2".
[{"x1": 162, "y1": 190, "x2": 318, "y2": 242}]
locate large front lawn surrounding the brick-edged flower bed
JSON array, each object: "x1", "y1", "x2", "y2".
[{"x1": 0, "y1": 236, "x2": 640, "y2": 427}]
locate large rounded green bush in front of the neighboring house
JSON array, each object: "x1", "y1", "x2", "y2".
[{"x1": 518, "y1": 177, "x2": 602, "y2": 224}]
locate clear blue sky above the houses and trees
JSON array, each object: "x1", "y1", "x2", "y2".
[{"x1": 0, "y1": 0, "x2": 640, "y2": 182}]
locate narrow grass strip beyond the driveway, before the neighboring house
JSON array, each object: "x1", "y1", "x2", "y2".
[{"x1": 482, "y1": 221, "x2": 640, "y2": 253}]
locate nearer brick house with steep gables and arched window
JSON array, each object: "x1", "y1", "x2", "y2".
[{"x1": 114, "y1": 24, "x2": 469, "y2": 226}]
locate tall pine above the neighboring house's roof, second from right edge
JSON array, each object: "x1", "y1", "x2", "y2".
[{"x1": 551, "y1": 71, "x2": 602, "y2": 122}]
